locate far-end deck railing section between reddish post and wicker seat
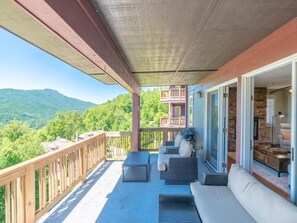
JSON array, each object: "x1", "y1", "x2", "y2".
[{"x1": 139, "y1": 128, "x2": 183, "y2": 151}]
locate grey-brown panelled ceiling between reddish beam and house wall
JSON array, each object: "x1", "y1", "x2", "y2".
[{"x1": 91, "y1": 0, "x2": 297, "y2": 86}]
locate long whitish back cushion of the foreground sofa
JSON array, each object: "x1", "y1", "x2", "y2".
[{"x1": 228, "y1": 164, "x2": 297, "y2": 223}]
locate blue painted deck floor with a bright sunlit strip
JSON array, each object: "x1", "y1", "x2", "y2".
[{"x1": 39, "y1": 154, "x2": 208, "y2": 223}]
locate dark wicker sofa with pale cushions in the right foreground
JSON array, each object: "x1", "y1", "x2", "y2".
[{"x1": 159, "y1": 164, "x2": 297, "y2": 223}]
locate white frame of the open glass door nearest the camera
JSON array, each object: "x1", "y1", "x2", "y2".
[{"x1": 240, "y1": 54, "x2": 297, "y2": 204}]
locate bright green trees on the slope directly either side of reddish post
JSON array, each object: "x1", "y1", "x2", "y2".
[{"x1": 83, "y1": 89, "x2": 168, "y2": 131}]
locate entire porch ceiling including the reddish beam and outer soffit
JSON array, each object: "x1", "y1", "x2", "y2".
[{"x1": 0, "y1": 0, "x2": 297, "y2": 88}]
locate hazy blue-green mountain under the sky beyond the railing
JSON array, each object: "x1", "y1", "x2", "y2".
[{"x1": 0, "y1": 89, "x2": 95, "y2": 129}]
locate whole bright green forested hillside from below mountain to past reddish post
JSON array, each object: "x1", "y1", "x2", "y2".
[{"x1": 41, "y1": 89, "x2": 168, "y2": 141}]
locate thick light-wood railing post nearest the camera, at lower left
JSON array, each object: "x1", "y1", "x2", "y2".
[{"x1": 24, "y1": 164, "x2": 35, "y2": 223}]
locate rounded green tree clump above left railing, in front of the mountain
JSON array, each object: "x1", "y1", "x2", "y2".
[{"x1": 40, "y1": 111, "x2": 84, "y2": 141}]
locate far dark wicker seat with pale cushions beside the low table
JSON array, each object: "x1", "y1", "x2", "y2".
[{"x1": 158, "y1": 135, "x2": 198, "y2": 184}]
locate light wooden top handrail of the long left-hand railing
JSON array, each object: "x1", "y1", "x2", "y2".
[{"x1": 0, "y1": 133, "x2": 105, "y2": 179}]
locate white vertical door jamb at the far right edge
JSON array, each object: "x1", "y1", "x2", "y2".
[{"x1": 290, "y1": 61, "x2": 297, "y2": 204}]
